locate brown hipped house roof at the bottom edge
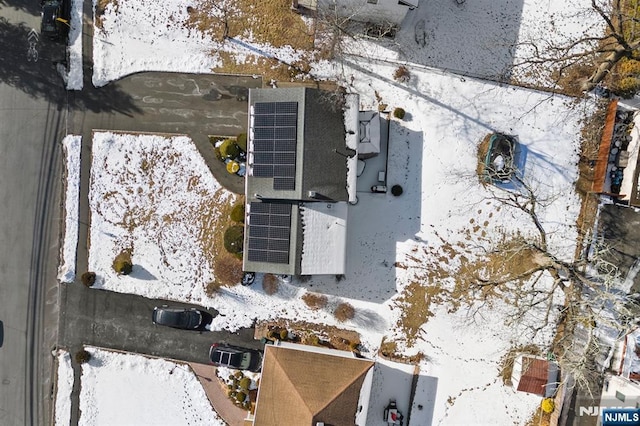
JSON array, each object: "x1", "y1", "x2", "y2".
[{"x1": 254, "y1": 345, "x2": 374, "y2": 426}]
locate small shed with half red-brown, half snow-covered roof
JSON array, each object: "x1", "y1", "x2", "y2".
[{"x1": 511, "y1": 355, "x2": 558, "y2": 397}]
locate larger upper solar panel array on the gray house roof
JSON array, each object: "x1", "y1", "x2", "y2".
[{"x1": 252, "y1": 102, "x2": 298, "y2": 190}]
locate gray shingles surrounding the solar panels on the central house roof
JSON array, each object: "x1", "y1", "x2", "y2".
[{"x1": 243, "y1": 87, "x2": 355, "y2": 275}]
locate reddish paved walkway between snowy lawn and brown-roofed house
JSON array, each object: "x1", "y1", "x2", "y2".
[{"x1": 189, "y1": 362, "x2": 248, "y2": 426}]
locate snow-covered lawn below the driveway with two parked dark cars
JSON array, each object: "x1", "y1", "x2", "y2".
[{"x1": 79, "y1": 348, "x2": 225, "y2": 426}]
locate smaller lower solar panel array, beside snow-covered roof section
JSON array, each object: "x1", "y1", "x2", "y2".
[{"x1": 247, "y1": 202, "x2": 291, "y2": 263}]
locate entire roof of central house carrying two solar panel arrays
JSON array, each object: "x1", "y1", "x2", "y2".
[{"x1": 243, "y1": 87, "x2": 358, "y2": 275}]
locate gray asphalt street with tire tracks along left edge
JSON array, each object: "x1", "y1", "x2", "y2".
[{"x1": 0, "y1": 0, "x2": 66, "y2": 426}]
